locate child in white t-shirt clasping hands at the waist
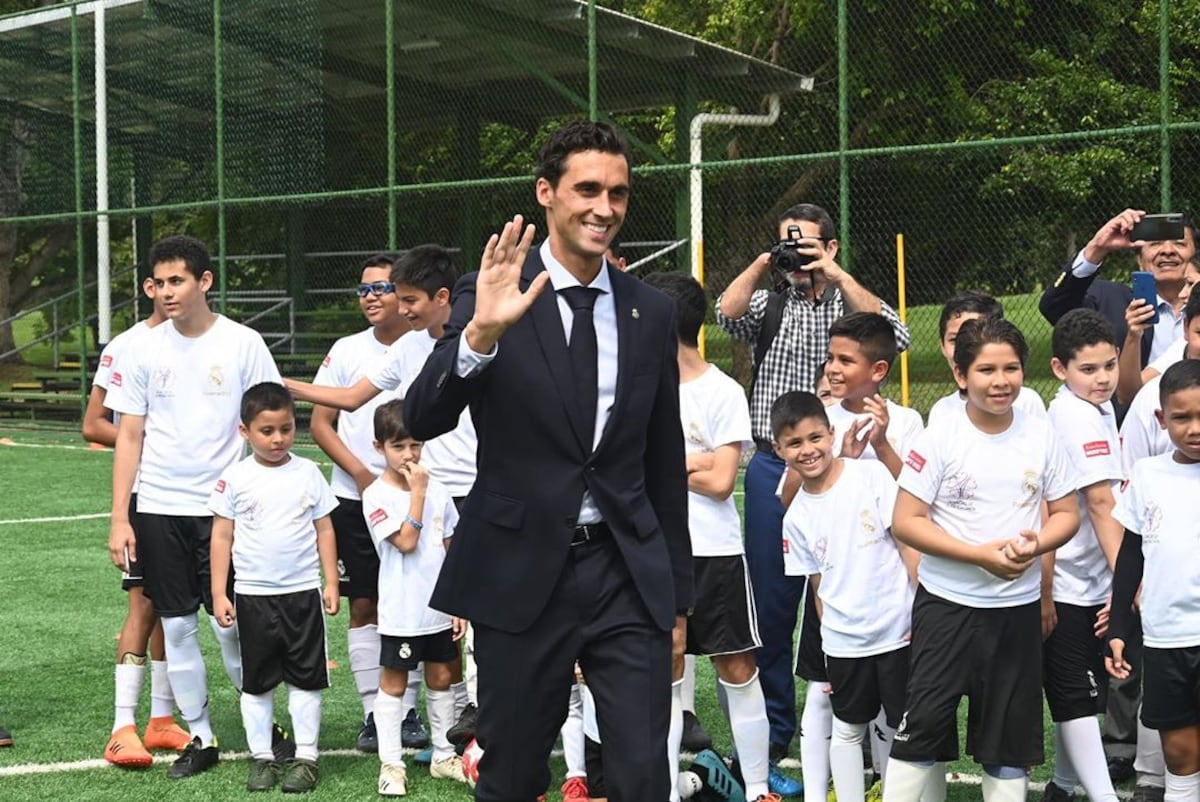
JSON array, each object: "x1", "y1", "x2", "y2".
[{"x1": 883, "y1": 318, "x2": 1079, "y2": 802}]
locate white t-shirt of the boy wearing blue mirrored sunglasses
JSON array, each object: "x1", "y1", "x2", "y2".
[{"x1": 312, "y1": 328, "x2": 400, "y2": 499}]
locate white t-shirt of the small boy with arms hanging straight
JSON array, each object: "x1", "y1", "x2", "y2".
[{"x1": 209, "y1": 454, "x2": 337, "y2": 595}]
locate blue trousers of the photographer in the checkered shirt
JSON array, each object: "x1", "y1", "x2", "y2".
[{"x1": 744, "y1": 450, "x2": 805, "y2": 747}]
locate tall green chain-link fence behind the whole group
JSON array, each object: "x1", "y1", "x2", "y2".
[{"x1": 0, "y1": 0, "x2": 1200, "y2": 411}]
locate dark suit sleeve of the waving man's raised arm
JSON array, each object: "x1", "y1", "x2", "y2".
[{"x1": 404, "y1": 273, "x2": 487, "y2": 441}]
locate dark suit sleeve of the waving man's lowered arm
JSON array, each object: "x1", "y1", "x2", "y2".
[{"x1": 644, "y1": 313, "x2": 695, "y2": 612}]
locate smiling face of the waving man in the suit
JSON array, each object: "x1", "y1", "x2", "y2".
[{"x1": 536, "y1": 150, "x2": 629, "y2": 273}]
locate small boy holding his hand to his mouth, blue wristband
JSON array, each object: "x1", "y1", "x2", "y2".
[{"x1": 362, "y1": 400, "x2": 467, "y2": 796}]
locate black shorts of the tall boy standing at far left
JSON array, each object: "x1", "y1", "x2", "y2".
[{"x1": 138, "y1": 513, "x2": 233, "y2": 618}]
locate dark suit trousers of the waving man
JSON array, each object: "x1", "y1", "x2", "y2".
[{"x1": 475, "y1": 528, "x2": 671, "y2": 802}]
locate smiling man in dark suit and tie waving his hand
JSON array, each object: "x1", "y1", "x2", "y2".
[{"x1": 404, "y1": 122, "x2": 692, "y2": 802}]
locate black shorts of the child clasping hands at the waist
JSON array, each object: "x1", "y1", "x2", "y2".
[{"x1": 892, "y1": 587, "x2": 1044, "y2": 766}]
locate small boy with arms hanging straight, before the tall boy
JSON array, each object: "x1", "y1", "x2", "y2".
[{"x1": 209, "y1": 382, "x2": 341, "y2": 794}]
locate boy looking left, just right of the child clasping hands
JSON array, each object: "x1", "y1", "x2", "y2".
[{"x1": 1042, "y1": 309, "x2": 1124, "y2": 802}]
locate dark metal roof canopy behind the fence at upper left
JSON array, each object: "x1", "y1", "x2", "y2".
[{"x1": 0, "y1": 0, "x2": 812, "y2": 163}]
